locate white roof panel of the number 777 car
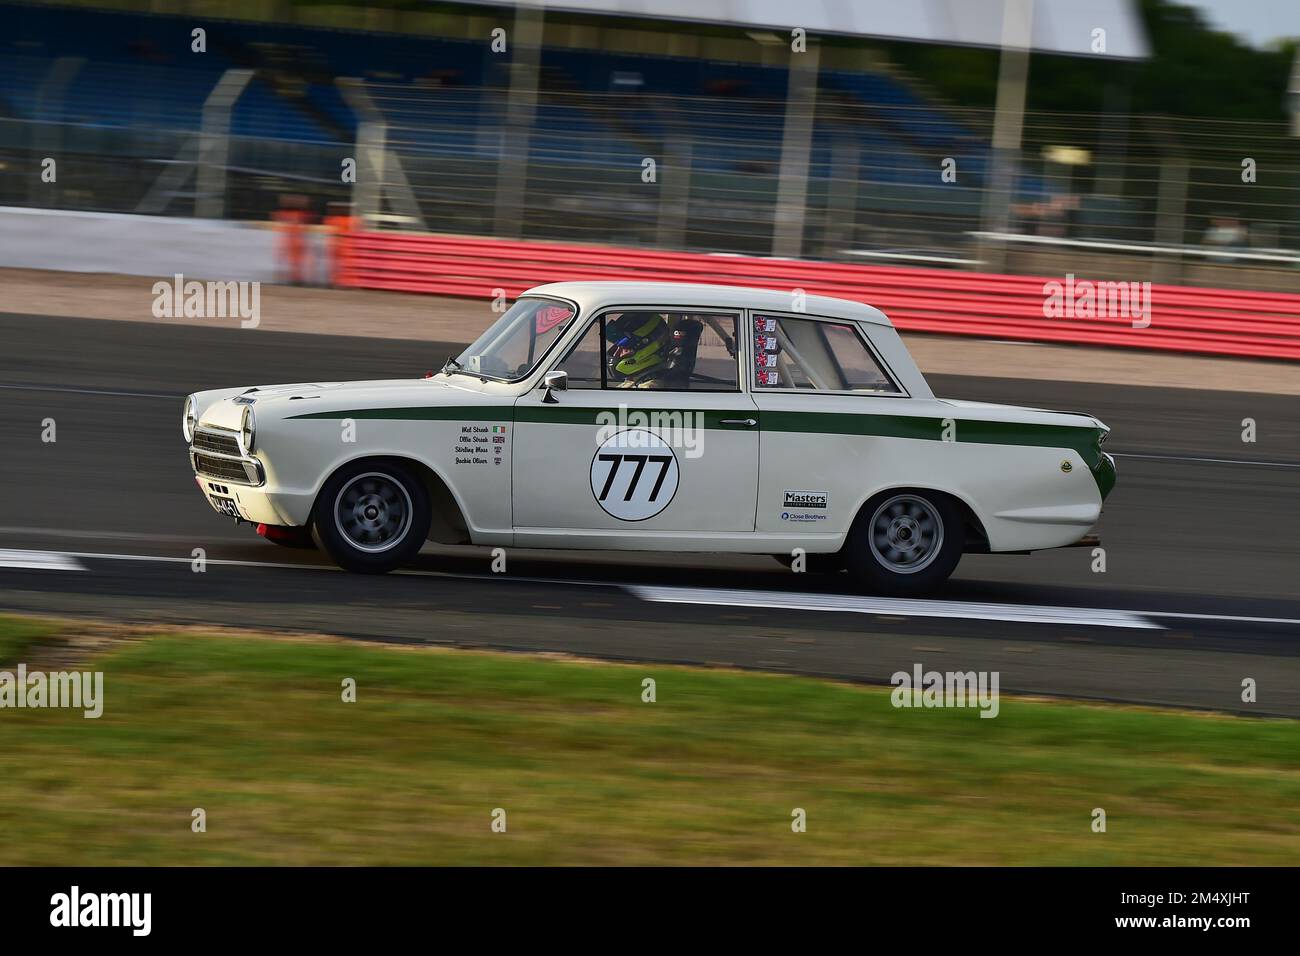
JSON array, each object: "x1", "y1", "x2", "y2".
[{"x1": 524, "y1": 282, "x2": 893, "y2": 328}]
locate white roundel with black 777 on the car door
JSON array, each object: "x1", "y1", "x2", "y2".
[{"x1": 592, "y1": 428, "x2": 679, "y2": 522}]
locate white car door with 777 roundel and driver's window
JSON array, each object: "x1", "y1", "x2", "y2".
[{"x1": 512, "y1": 306, "x2": 759, "y2": 535}]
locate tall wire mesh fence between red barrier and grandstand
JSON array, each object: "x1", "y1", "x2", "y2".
[{"x1": 0, "y1": 57, "x2": 1300, "y2": 287}]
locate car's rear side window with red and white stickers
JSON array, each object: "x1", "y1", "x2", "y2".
[{"x1": 754, "y1": 315, "x2": 900, "y2": 394}]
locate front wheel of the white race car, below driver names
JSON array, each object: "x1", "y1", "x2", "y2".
[{"x1": 312, "y1": 460, "x2": 430, "y2": 574}]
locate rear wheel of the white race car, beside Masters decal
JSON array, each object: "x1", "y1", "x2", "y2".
[{"x1": 845, "y1": 490, "x2": 966, "y2": 597}]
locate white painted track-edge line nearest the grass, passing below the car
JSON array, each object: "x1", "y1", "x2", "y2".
[{"x1": 0, "y1": 550, "x2": 1300, "y2": 631}]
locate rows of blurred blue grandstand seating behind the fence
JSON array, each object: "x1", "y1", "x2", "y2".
[{"x1": 0, "y1": 5, "x2": 987, "y2": 251}]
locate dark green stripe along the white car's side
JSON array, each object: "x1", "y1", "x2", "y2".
[{"x1": 291, "y1": 405, "x2": 1115, "y2": 498}]
